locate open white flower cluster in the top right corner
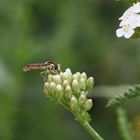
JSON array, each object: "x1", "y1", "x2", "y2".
[{"x1": 116, "y1": 2, "x2": 140, "y2": 39}]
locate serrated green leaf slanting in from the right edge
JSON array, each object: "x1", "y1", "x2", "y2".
[{"x1": 107, "y1": 85, "x2": 140, "y2": 107}]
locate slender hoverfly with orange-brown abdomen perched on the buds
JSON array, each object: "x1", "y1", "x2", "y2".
[{"x1": 23, "y1": 61, "x2": 60, "y2": 72}]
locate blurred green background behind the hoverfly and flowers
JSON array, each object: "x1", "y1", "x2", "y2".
[{"x1": 0, "y1": 0, "x2": 140, "y2": 140}]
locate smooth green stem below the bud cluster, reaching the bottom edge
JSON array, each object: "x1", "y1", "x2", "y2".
[{"x1": 80, "y1": 122, "x2": 103, "y2": 140}]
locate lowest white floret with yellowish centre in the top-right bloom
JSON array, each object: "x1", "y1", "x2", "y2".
[{"x1": 116, "y1": 26, "x2": 134, "y2": 38}]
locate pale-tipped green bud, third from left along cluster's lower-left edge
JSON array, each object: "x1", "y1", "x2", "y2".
[{"x1": 55, "y1": 84, "x2": 64, "y2": 100}]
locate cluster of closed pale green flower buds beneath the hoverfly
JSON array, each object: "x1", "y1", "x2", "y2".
[{"x1": 44, "y1": 69, "x2": 94, "y2": 120}]
